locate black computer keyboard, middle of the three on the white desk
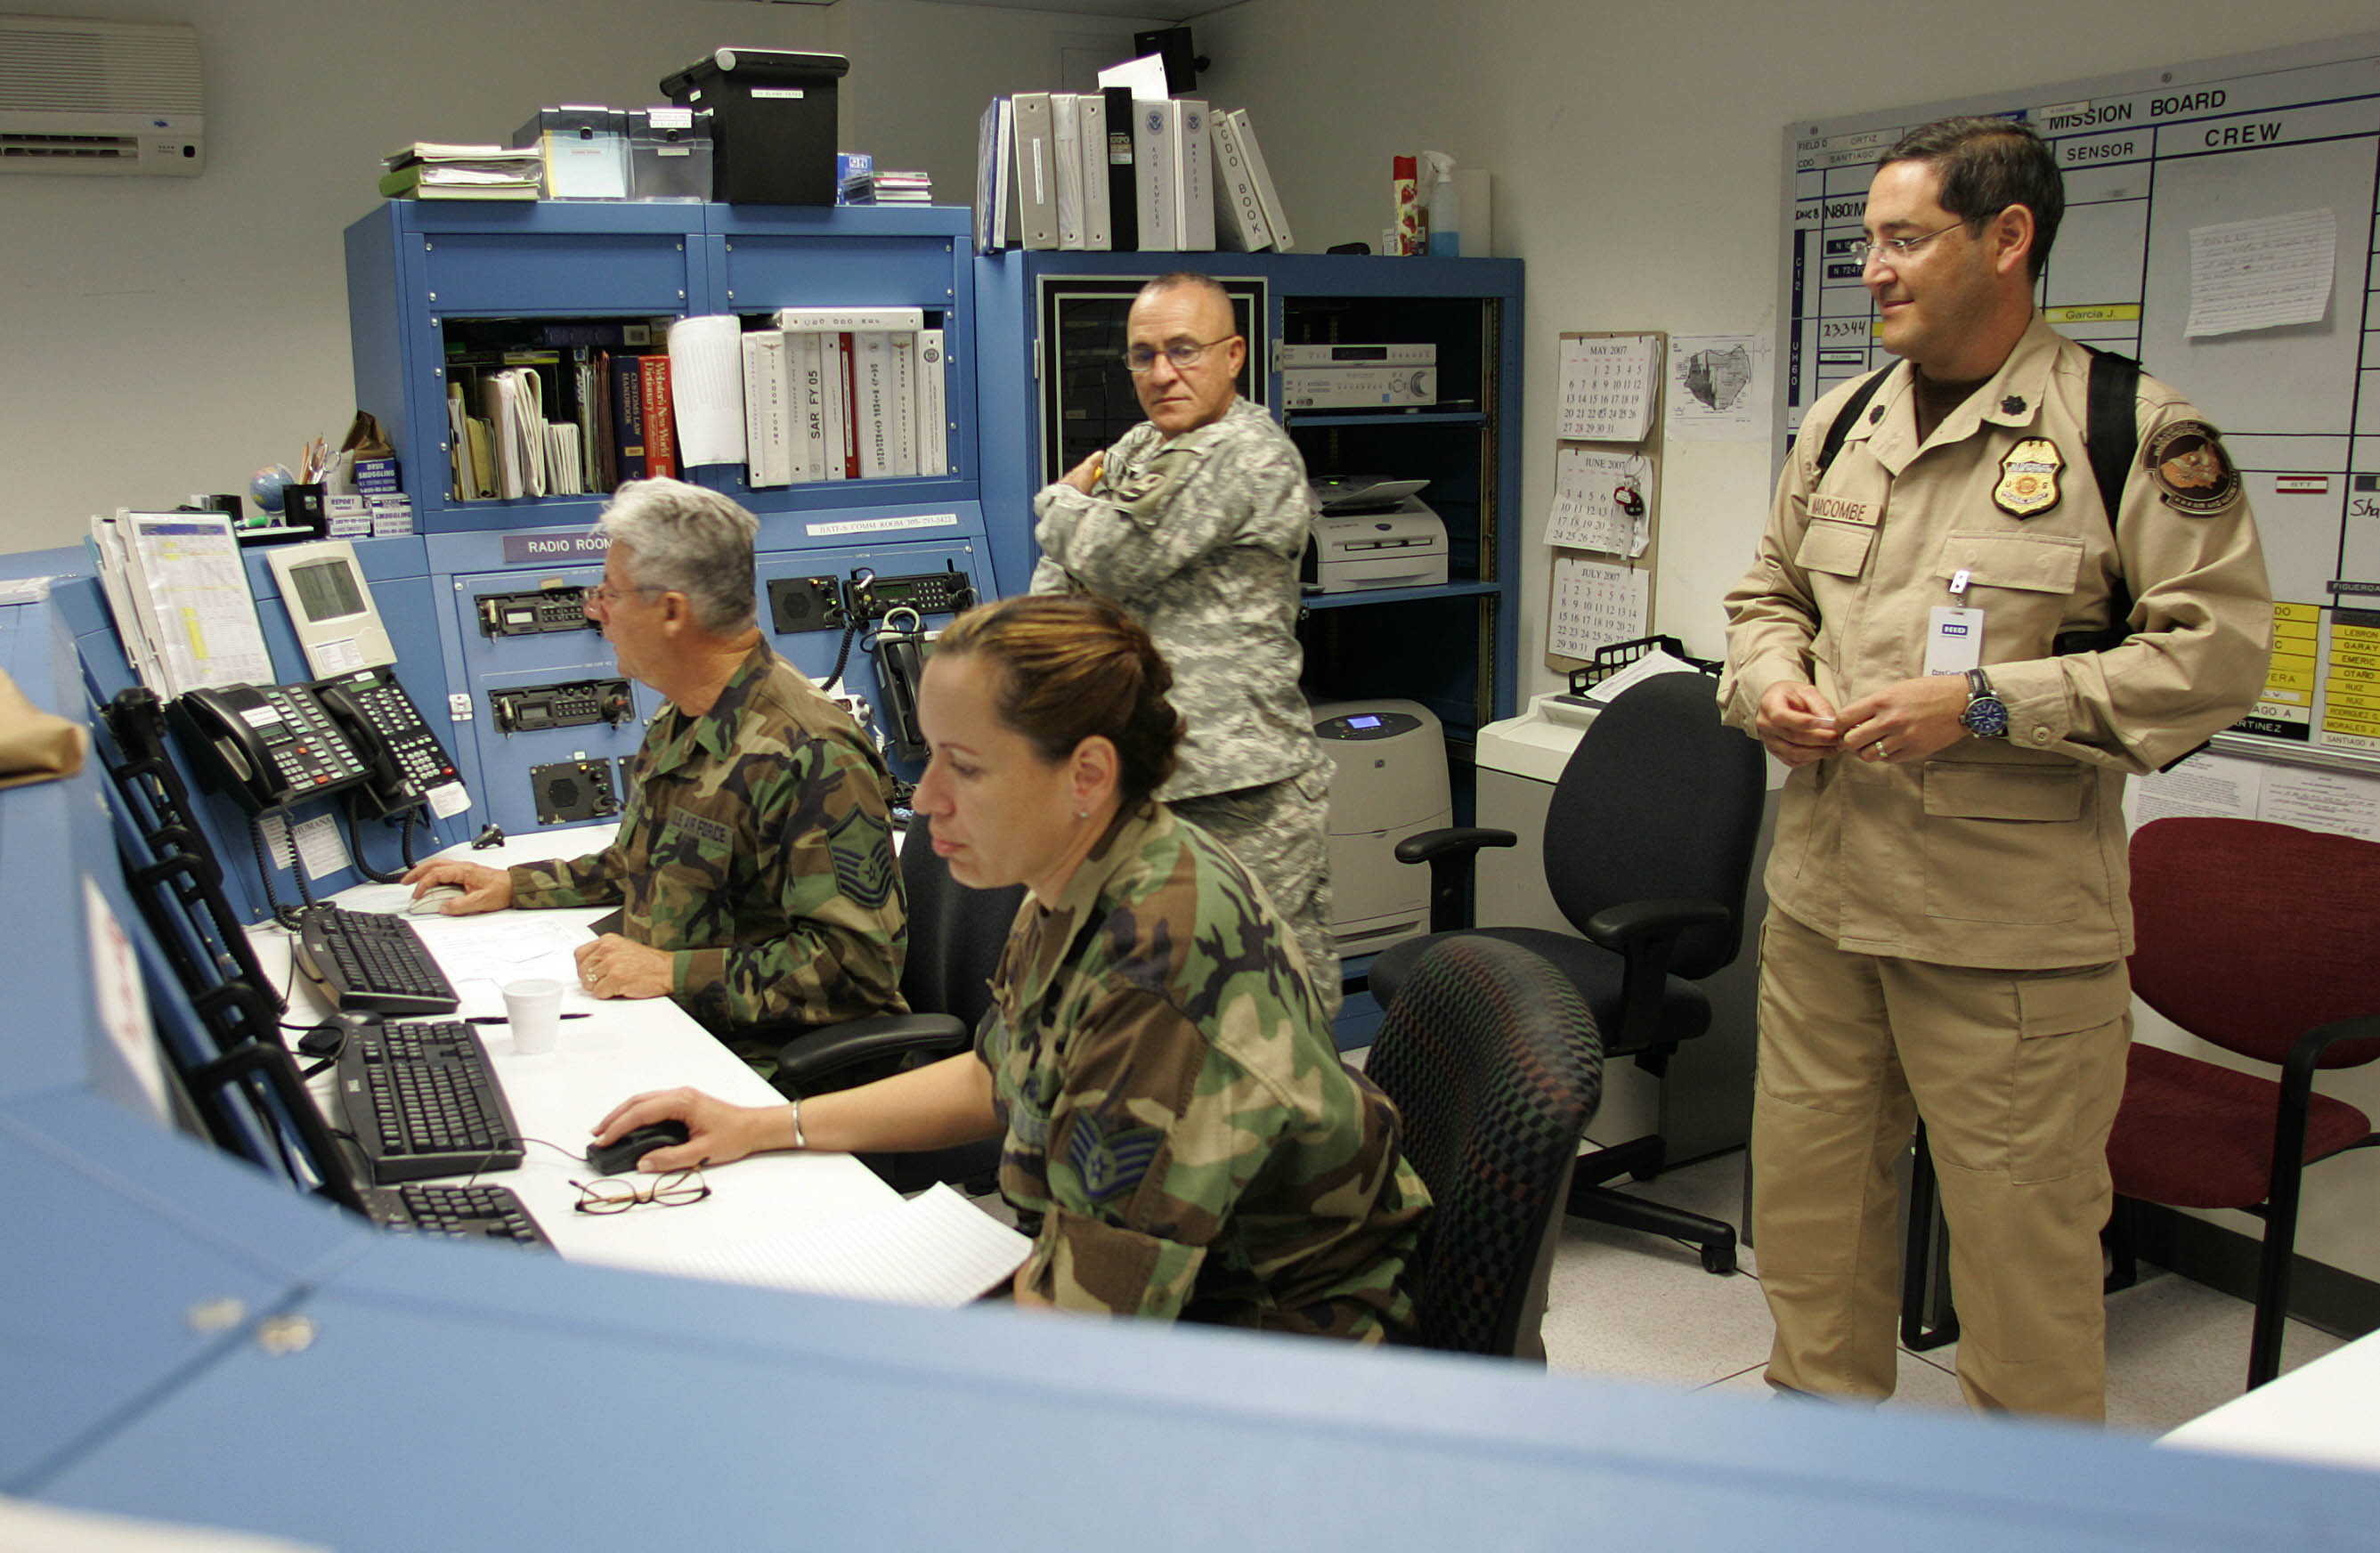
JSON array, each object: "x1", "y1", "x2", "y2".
[{"x1": 338, "y1": 1022, "x2": 521, "y2": 1186}]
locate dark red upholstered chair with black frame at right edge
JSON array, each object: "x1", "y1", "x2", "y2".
[{"x1": 2107, "y1": 819, "x2": 2380, "y2": 1388}]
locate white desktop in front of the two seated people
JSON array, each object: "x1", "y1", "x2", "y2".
[{"x1": 248, "y1": 826, "x2": 899, "y2": 1267}]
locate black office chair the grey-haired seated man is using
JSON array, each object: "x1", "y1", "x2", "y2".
[{"x1": 774, "y1": 826, "x2": 1026, "y2": 1191}]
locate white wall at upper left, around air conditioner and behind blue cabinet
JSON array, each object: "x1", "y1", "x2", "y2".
[{"x1": 0, "y1": 0, "x2": 1147, "y2": 553}]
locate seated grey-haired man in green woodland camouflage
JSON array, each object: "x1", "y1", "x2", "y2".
[{"x1": 404, "y1": 479, "x2": 906, "y2": 1077}]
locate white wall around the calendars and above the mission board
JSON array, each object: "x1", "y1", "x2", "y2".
[{"x1": 1195, "y1": 0, "x2": 2380, "y2": 1279}]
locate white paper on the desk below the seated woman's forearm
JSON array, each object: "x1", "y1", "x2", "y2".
[{"x1": 572, "y1": 1182, "x2": 1033, "y2": 1310}]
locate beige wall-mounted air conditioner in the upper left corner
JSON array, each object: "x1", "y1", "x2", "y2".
[{"x1": 0, "y1": 17, "x2": 207, "y2": 179}]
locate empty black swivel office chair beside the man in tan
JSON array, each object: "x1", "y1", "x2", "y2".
[{"x1": 1371, "y1": 674, "x2": 1764, "y2": 1272}]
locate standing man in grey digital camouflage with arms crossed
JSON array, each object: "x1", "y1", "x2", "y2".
[{"x1": 1033, "y1": 272, "x2": 1340, "y2": 1017}]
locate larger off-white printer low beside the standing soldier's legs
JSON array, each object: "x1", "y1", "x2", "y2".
[{"x1": 1312, "y1": 700, "x2": 1454, "y2": 960}]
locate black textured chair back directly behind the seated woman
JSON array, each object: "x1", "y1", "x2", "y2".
[{"x1": 1364, "y1": 936, "x2": 1604, "y2": 1362}]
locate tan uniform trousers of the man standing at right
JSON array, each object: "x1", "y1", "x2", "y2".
[{"x1": 1751, "y1": 910, "x2": 2132, "y2": 1419}]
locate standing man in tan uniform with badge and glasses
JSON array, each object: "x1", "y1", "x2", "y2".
[{"x1": 1721, "y1": 119, "x2": 2273, "y2": 1419}]
